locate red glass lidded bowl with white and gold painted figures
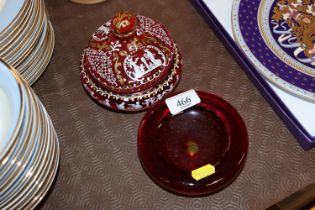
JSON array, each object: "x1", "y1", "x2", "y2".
[{"x1": 81, "y1": 12, "x2": 182, "y2": 111}]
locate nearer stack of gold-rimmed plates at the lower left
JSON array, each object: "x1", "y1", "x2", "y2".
[{"x1": 0, "y1": 60, "x2": 59, "y2": 209}]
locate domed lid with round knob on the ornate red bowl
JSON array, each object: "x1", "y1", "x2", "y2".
[{"x1": 82, "y1": 12, "x2": 175, "y2": 94}]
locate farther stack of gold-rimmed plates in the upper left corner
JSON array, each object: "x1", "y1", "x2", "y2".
[{"x1": 0, "y1": 0, "x2": 55, "y2": 84}]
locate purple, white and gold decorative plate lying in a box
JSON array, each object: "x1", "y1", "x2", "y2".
[{"x1": 232, "y1": 0, "x2": 315, "y2": 102}]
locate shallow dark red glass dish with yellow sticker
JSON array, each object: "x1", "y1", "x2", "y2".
[{"x1": 138, "y1": 91, "x2": 248, "y2": 196}]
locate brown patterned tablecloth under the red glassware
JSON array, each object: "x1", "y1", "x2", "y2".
[{"x1": 33, "y1": 0, "x2": 315, "y2": 210}]
